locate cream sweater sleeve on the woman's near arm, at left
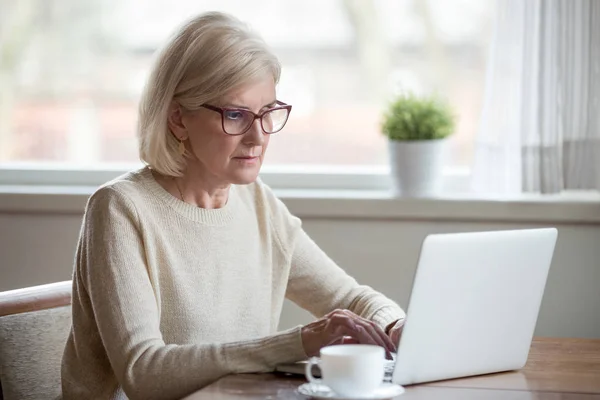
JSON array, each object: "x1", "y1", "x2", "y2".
[{"x1": 74, "y1": 187, "x2": 306, "y2": 399}]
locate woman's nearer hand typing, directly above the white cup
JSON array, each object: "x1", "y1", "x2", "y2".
[{"x1": 302, "y1": 310, "x2": 396, "y2": 358}]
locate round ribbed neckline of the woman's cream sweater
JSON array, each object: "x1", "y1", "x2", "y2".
[{"x1": 140, "y1": 166, "x2": 239, "y2": 225}]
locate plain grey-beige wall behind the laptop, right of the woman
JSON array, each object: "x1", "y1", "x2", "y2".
[{"x1": 282, "y1": 220, "x2": 600, "y2": 338}]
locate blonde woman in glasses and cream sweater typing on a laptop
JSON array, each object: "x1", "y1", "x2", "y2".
[{"x1": 62, "y1": 13, "x2": 404, "y2": 399}]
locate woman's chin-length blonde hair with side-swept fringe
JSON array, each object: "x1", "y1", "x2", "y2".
[{"x1": 137, "y1": 12, "x2": 281, "y2": 176}]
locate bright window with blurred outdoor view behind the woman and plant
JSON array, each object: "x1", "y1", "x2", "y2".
[{"x1": 0, "y1": 0, "x2": 494, "y2": 177}]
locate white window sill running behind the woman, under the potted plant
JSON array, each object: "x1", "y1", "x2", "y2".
[{"x1": 0, "y1": 185, "x2": 600, "y2": 224}]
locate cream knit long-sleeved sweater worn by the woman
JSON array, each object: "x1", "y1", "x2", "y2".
[{"x1": 62, "y1": 168, "x2": 404, "y2": 399}]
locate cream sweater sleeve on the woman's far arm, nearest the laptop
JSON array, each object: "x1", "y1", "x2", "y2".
[{"x1": 266, "y1": 184, "x2": 405, "y2": 329}]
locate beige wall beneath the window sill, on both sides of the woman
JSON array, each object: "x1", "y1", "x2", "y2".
[{"x1": 0, "y1": 195, "x2": 600, "y2": 338}]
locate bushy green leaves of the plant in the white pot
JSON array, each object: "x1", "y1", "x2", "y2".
[{"x1": 381, "y1": 94, "x2": 455, "y2": 141}]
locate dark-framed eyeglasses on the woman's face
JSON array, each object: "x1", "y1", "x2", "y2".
[{"x1": 202, "y1": 100, "x2": 292, "y2": 136}]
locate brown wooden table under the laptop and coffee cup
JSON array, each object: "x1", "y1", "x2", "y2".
[{"x1": 185, "y1": 338, "x2": 600, "y2": 400}]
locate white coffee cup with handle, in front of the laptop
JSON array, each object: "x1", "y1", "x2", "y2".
[{"x1": 305, "y1": 344, "x2": 385, "y2": 397}]
